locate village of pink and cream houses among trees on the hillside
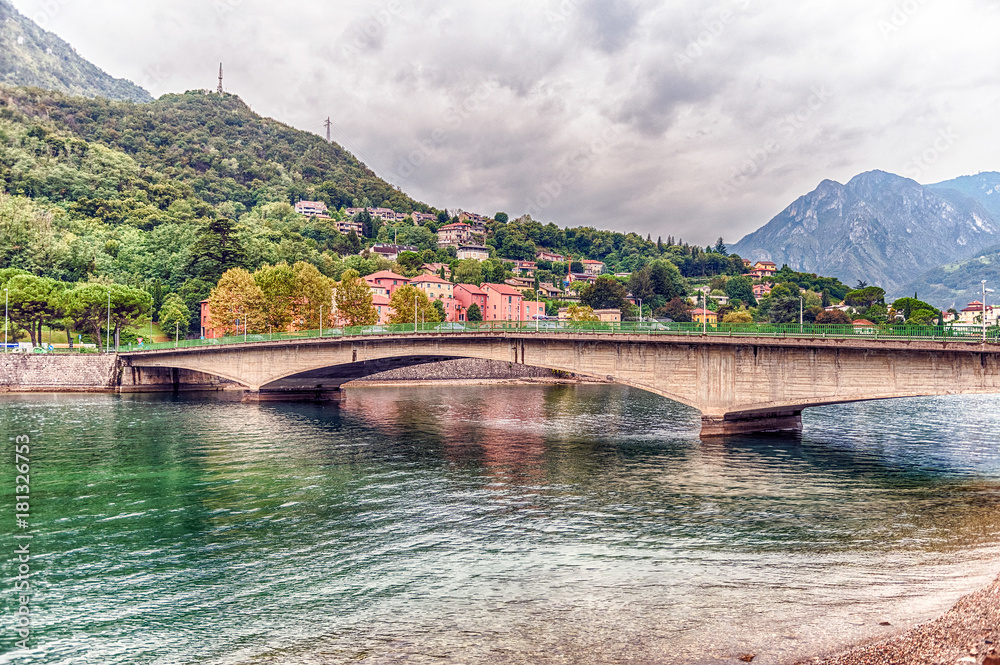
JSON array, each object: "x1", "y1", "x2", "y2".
[{"x1": 184, "y1": 200, "x2": 980, "y2": 338}]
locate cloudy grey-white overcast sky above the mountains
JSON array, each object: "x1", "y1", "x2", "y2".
[{"x1": 13, "y1": 0, "x2": 1000, "y2": 245}]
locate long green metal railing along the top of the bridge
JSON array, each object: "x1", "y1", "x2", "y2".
[{"x1": 121, "y1": 321, "x2": 1000, "y2": 351}]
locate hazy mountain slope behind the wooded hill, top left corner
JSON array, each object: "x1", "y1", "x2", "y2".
[{"x1": 0, "y1": 0, "x2": 153, "y2": 102}]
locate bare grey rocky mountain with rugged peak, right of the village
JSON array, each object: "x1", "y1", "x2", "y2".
[{"x1": 730, "y1": 171, "x2": 1000, "y2": 294}]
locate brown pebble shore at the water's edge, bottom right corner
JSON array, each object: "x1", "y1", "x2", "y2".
[{"x1": 796, "y1": 577, "x2": 1000, "y2": 665}]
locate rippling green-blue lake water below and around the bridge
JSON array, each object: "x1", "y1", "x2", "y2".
[{"x1": 0, "y1": 386, "x2": 1000, "y2": 665}]
